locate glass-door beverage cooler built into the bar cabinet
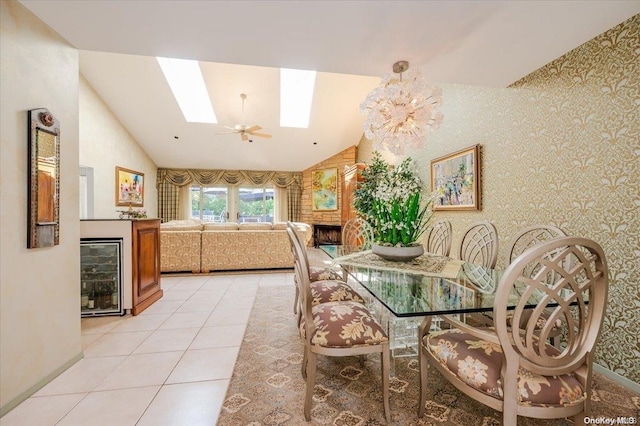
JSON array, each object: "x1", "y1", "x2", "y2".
[{"x1": 80, "y1": 238, "x2": 125, "y2": 317}]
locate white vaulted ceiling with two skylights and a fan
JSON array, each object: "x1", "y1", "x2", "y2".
[{"x1": 20, "y1": 0, "x2": 640, "y2": 171}]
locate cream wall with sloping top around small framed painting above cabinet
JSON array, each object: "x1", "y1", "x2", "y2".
[{"x1": 76, "y1": 75, "x2": 158, "y2": 219}]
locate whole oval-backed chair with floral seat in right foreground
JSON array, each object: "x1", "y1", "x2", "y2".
[{"x1": 418, "y1": 237, "x2": 608, "y2": 425}]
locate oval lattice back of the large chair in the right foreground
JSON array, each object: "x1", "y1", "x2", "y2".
[{"x1": 493, "y1": 237, "x2": 608, "y2": 381}]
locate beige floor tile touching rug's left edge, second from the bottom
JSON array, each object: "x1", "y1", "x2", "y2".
[{"x1": 166, "y1": 347, "x2": 240, "y2": 384}]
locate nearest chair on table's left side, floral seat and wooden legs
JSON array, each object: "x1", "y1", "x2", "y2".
[{"x1": 287, "y1": 228, "x2": 391, "y2": 423}]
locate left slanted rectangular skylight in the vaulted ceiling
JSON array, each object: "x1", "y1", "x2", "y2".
[{"x1": 156, "y1": 57, "x2": 218, "y2": 124}]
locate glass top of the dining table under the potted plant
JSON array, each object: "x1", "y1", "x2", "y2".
[{"x1": 319, "y1": 245, "x2": 516, "y2": 318}]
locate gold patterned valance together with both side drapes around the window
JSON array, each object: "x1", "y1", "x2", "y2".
[{"x1": 156, "y1": 169, "x2": 302, "y2": 222}]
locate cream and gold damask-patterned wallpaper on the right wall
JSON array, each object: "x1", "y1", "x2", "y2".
[{"x1": 358, "y1": 15, "x2": 640, "y2": 383}]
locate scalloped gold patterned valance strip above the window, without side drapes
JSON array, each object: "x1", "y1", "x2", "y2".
[{"x1": 156, "y1": 169, "x2": 302, "y2": 188}]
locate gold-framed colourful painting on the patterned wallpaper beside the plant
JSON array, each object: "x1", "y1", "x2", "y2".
[{"x1": 431, "y1": 145, "x2": 481, "y2": 210}]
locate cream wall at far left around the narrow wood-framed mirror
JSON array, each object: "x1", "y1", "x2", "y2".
[{"x1": 0, "y1": 0, "x2": 82, "y2": 415}]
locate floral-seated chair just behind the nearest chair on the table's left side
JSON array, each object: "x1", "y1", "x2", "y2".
[{"x1": 287, "y1": 222, "x2": 365, "y2": 323}]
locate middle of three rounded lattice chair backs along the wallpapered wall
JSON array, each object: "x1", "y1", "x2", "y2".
[{"x1": 459, "y1": 221, "x2": 498, "y2": 268}]
